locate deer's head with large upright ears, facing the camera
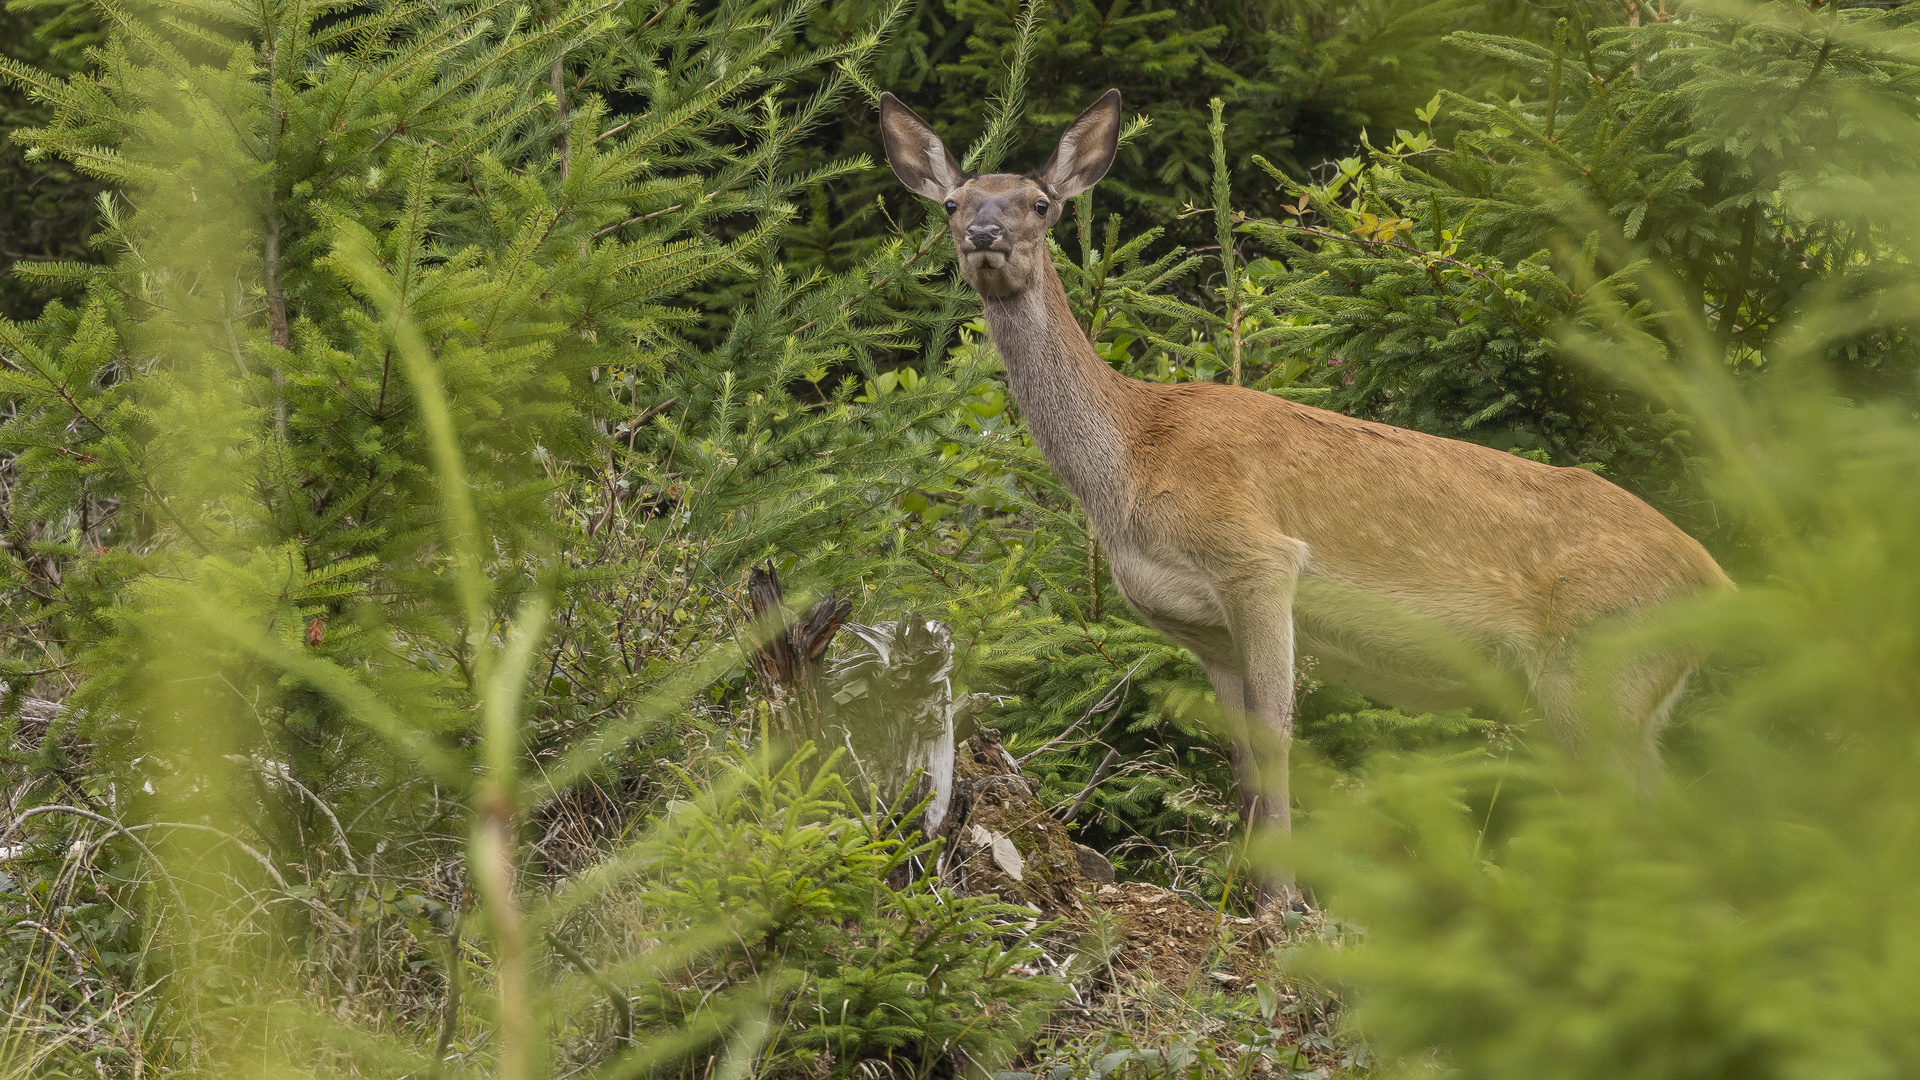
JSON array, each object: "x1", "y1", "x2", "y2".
[{"x1": 879, "y1": 90, "x2": 1119, "y2": 300}]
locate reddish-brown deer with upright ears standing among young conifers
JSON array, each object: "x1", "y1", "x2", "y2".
[{"x1": 879, "y1": 90, "x2": 1732, "y2": 905}]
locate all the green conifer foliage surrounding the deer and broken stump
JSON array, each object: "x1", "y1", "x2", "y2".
[{"x1": 11, "y1": 0, "x2": 1920, "y2": 1078}]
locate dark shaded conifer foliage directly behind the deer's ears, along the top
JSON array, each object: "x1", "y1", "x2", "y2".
[{"x1": 835, "y1": 0, "x2": 1582, "y2": 244}]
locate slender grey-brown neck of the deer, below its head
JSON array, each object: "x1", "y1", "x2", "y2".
[{"x1": 983, "y1": 267, "x2": 1131, "y2": 528}]
